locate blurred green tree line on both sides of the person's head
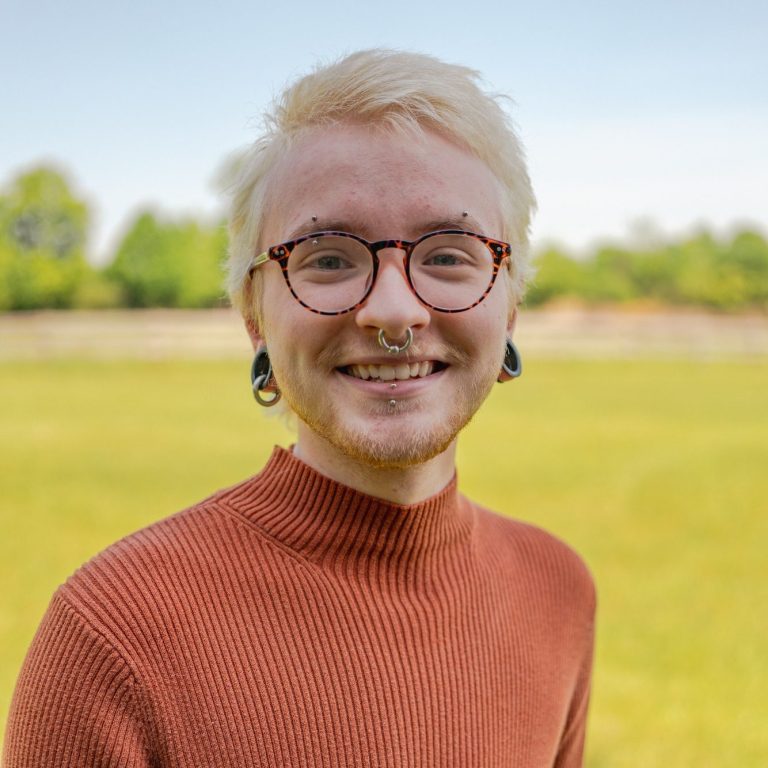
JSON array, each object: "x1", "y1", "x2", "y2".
[{"x1": 0, "y1": 167, "x2": 768, "y2": 312}]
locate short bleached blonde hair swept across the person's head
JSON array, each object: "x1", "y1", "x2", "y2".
[{"x1": 227, "y1": 49, "x2": 536, "y2": 323}]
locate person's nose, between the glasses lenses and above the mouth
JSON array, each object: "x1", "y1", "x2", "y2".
[{"x1": 355, "y1": 249, "x2": 430, "y2": 343}]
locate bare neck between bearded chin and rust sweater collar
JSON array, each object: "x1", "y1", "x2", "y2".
[{"x1": 293, "y1": 420, "x2": 456, "y2": 505}]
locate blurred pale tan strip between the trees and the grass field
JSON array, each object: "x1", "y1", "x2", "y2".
[{"x1": 0, "y1": 308, "x2": 768, "y2": 360}]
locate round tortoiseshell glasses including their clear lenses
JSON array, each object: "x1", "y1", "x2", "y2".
[{"x1": 248, "y1": 229, "x2": 512, "y2": 315}]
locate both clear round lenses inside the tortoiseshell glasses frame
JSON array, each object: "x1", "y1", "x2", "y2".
[{"x1": 288, "y1": 234, "x2": 493, "y2": 312}]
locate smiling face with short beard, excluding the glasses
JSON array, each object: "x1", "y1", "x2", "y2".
[{"x1": 253, "y1": 125, "x2": 511, "y2": 468}]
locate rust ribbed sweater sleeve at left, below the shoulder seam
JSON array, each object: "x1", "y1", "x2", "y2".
[{"x1": 3, "y1": 592, "x2": 150, "y2": 768}]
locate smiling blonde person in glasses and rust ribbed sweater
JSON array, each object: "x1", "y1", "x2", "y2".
[{"x1": 5, "y1": 50, "x2": 595, "y2": 768}]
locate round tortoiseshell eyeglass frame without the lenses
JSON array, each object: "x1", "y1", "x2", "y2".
[{"x1": 248, "y1": 229, "x2": 512, "y2": 315}]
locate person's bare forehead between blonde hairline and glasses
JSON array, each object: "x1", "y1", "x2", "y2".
[{"x1": 263, "y1": 125, "x2": 503, "y2": 244}]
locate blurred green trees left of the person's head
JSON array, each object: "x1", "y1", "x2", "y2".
[{"x1": 0, "y1": 167, "x2": 227, "y2": 311}]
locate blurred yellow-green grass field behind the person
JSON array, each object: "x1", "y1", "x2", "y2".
[{"x1": 0, "y1": 359, "x2": 768, "y2": 768}]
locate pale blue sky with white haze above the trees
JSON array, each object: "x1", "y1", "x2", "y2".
[{"x1": 0, "y1": 0, "x2": 768, "y2": 262}]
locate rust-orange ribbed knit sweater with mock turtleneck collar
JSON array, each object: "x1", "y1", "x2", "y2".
[{"x1": 4, "y1": 448, "x2": 594, "y2": 768}]
